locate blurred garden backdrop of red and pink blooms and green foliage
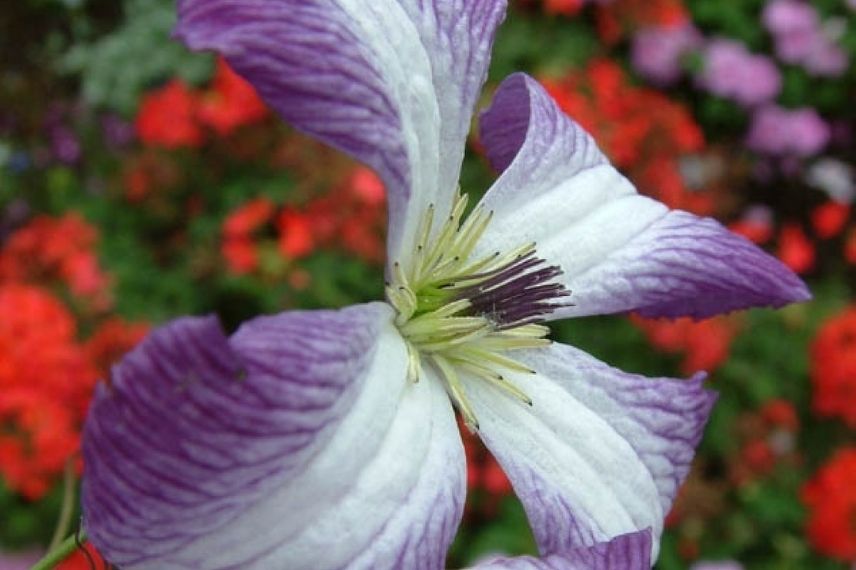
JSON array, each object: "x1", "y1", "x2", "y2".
[{"x1": 0, "y1": 0, "x2": 856, "y2": 570}]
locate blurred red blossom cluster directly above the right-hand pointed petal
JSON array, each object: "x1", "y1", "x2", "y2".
[{"x1": 542, "y1": 59, "x2": 713, "y2": 214}]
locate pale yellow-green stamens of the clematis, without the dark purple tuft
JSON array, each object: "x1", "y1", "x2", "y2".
[{"x1": 386, "y1": 191, "x2": 550, "y2": 429}]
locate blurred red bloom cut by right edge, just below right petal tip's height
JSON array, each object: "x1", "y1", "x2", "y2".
[{"x1": 811, "y1": 305, "x2": 856, "y2": 428}]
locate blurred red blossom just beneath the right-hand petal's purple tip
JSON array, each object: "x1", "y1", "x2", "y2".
[{"x1": 630, "y1": 315, "x2": 737, "y2": 374}]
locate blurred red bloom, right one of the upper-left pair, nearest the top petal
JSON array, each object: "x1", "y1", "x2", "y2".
[{"x1": 198, "y1": 58, "x2": 268, "y2": 137}]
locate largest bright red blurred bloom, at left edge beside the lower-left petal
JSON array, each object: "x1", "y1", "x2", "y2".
[{"x1": 0, "y1": 283, "x2": 98, "y2": 500}]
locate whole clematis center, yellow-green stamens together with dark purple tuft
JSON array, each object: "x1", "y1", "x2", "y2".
[{"x1": 386, "y1": 190, "x2": 570, "y2": 430}]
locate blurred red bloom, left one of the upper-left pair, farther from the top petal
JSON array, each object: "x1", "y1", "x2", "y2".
[{"x1": 136, "y1": 79, "x2": 203, "y2": 148}]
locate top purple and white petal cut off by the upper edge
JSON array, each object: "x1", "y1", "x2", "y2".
[{"x1": 176, "y1": 0, "x2": 506, "y2": 263}]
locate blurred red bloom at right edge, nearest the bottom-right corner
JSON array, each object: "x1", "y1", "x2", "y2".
[{"x1": 802, "y1": 447, "x2": 856, "y2": 562}]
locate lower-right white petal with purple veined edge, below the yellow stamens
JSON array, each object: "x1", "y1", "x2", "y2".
[{"x1": 467, "y1": 344, "x2": 714, "y2": 555}]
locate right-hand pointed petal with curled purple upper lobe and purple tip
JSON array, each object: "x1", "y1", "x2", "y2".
[{"x1": 476, "y1": 74, "x2": 810, "y2": 318}]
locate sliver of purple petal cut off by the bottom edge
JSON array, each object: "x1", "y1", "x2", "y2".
[{"x1": 472, "y1": 530, "x2": 651, "y2": 570}]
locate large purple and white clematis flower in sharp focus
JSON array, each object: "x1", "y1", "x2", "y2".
[{"x1": 83, "y1": 0, "x2": 809, "y2": 570}]
